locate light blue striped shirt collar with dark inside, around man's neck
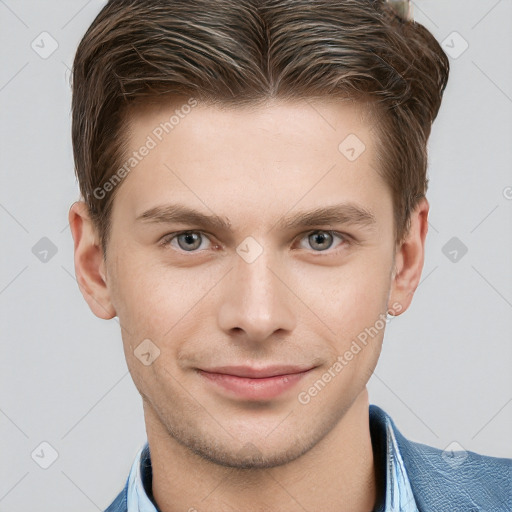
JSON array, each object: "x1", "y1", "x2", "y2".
[{"x1": 127, "y1": 405, "x2": 418, "y2": 512}]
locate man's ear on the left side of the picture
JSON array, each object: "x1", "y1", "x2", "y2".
[{"x1": 69, "y1": 201, "x2": 116, "y2": 320}]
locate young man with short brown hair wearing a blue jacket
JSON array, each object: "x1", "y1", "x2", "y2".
[{"x1": 69, "y1": 0, "x2": 512, "y2": 512}]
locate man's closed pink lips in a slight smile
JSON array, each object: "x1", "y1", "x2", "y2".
[{"x1": 198, "y1": 366, "x2": 315, "y2": 401}]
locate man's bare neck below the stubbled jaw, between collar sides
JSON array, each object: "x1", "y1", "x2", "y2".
[{"x1": 144, "y1": 389, "x2": 380, "y2": 512}]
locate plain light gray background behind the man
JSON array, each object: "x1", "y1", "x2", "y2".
[{"x1": 0, "y1": 0, "x2": 512, "y2": 512}]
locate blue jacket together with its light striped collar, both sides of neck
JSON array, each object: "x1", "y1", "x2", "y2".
[{"x1": 105, "y1": 405, "x2": 512, "y2": 512}]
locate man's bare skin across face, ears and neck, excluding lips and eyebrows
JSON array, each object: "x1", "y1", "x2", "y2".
[{"x1": 69, "y1": 98, "x2": 429, "y2": 512}]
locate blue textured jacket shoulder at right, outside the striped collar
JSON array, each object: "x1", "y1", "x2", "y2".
[{"x1": 374, "y1": 406, "x2": 512, "y2": 512}]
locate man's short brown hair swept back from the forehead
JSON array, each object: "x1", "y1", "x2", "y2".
[{"x1": 72, "y1": 0, "x2": 449, "y2": 257}]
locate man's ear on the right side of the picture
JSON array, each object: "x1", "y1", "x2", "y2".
[{"x1": 388, "y1": 198, "x2": 429, "y2": 315}]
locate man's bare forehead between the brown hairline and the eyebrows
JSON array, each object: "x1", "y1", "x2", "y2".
[{"x1": 110, "y1": 97, "x2": 385, "y2": 228}]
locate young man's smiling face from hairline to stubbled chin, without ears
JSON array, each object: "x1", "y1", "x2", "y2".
[{"x1": 77, "y1": 99, "x2": 420, "y2": 467}]
